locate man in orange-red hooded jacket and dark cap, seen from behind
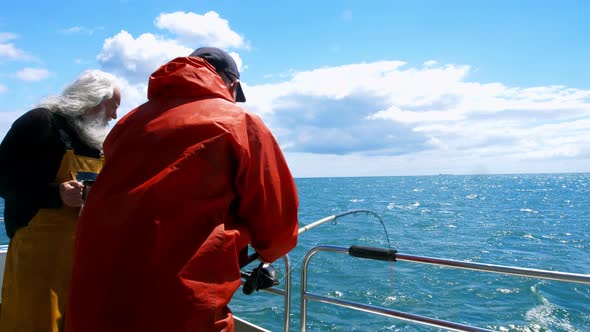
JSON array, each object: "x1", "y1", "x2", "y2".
[{"x1": 66, "y1": 47, "x2": 298, "y2": 332}]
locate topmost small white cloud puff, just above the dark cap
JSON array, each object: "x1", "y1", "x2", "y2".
[{"x1": 155, "y1": 11, "x2": 246, "y2": 49}]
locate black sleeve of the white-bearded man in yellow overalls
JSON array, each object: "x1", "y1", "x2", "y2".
[{"x1": 0, "y1": 109, "x2": 64, "y2": 208}]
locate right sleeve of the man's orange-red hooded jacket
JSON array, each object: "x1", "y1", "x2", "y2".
[{"x1": 236, "y1": 115, "x2": 299, "y2": 262}]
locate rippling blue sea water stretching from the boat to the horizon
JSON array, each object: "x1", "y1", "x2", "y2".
[{"x1": 0, "y1": 174, "x2": 590, "y2": 331}]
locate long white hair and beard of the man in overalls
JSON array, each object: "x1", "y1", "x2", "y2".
[{"x1": 38, "y1": 70, "x2": 119, "y2": 149}]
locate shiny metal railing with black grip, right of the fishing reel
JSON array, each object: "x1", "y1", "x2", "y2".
[{"x1": 300, "y1": 246, "x2": 590, "y2": 332}]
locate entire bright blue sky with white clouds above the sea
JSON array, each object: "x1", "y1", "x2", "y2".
[{"x1": 0, "y1": 0, "x2": 590, "y2": 177}]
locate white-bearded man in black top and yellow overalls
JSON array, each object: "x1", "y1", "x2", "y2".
[{"x1": 0, "y1": 70, "x2": 121, "y2": 332}]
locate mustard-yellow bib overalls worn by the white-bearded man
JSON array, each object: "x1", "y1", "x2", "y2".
[{"x1": 0, "y1": 146, "x2": 104, "y2": 332}]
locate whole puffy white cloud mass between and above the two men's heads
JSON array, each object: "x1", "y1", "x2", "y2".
[{"x1": 95, "y1": 12, "x2": 247, "y2": 116}]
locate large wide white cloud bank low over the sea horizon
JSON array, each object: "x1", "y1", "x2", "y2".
[{"x1": 238, "y1": 61, "x2": 590, "y2": 176}]
